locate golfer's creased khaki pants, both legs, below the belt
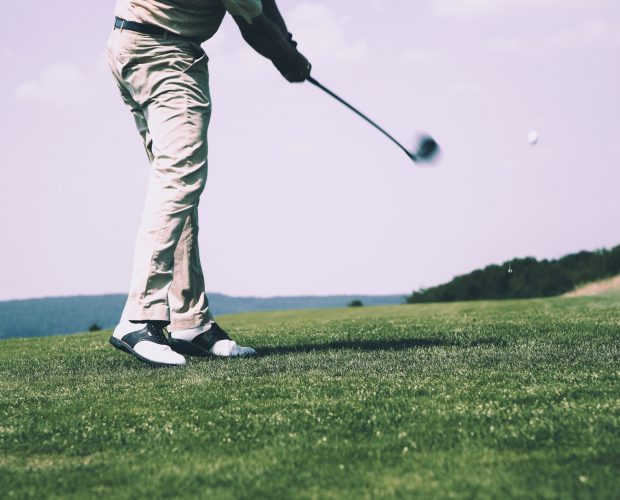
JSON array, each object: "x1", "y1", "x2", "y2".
[{"x1": 108, "y1": 30, "x2": 212, "y2": 330}]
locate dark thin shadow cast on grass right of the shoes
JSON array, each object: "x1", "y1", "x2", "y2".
[{"x1": 256, "y1": 339, "x2": 451, "y2": 357}]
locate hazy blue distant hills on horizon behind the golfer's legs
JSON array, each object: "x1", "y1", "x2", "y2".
[{"x1": 0, "y1": 293, "x2": 405, "y2": 339}]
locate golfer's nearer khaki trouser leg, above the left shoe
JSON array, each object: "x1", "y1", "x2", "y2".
[{"x1": 125, "y1": 65, "x2": 210, "y2": 320}]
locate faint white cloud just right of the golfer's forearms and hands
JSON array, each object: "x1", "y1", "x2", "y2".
[{"x1": 285, "y1": 2, "x2": 368, "y2": 63}]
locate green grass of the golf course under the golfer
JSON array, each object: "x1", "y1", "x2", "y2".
[{"x1": 0, "y1": 294, "x2": 620, "y2": 498}]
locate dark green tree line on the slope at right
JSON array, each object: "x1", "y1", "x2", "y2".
[{"x1": 405, "y1": 245, "x2": 620, "y2": 304}]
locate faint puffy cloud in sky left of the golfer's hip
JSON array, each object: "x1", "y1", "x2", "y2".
[{"x1": 13, "y1": 62, "x2": 95, "y2": 108}]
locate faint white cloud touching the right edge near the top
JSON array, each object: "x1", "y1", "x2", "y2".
[{"x1": 544, "y1": 19, "x2": 620, "y2": 49}]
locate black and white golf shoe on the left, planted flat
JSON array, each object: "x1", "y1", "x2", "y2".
[{"x1": 110, "y1": 321, "x2": 185, "y2": 366}]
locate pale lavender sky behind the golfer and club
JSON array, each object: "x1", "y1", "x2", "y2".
[{"x1": 0, "y1": 0, "x2": 620, "y2": 300}]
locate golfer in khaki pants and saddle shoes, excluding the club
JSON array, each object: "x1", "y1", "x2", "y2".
[{"x1": 108, "y1": 0, "x2": 310, "y2": 365}]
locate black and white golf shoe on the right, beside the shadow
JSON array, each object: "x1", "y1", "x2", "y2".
[{"x1": 169, "y1": 323, "x2": 256, "y2": 357}]
